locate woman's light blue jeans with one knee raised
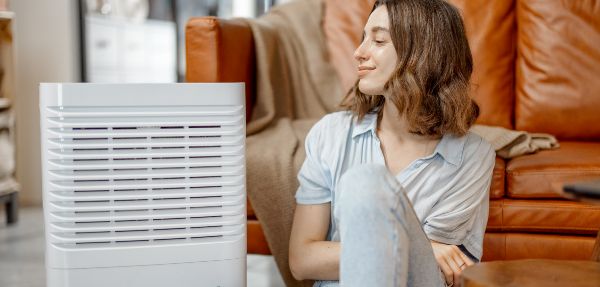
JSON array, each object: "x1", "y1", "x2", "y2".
[{"x1": 315, "y1": 164, "x2": 446, "y2": 287}]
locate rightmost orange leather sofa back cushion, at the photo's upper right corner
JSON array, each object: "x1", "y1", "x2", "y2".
[{"x1": 512, "y1": 0, "x2": 600, "y2": 140}]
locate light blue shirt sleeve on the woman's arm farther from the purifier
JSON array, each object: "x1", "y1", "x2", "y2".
[{"x1": 423, "y1": 137, "x2": 496, "y2": 245}]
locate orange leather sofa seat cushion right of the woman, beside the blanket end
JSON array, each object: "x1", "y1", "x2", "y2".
[{"x1": 506, "y1": 142, "x2": 600, "y2": 198}]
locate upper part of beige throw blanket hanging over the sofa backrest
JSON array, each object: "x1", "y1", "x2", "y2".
[{"x1": 247, "y1": 0, "x2": 342, "y2": 134}]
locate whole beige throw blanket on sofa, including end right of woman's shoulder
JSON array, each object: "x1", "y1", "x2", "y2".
[{"x1": 246, "y1": 0, "x2": 556, "y2": 286}]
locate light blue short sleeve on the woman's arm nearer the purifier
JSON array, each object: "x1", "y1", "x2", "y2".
[{"x1": 296, "y1": 118, "x2": 332, "y2": 204}]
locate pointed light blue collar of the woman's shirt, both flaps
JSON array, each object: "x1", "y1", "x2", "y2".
[{"x1": 352, "y1": 113, "x2": 467, "y2": 166}]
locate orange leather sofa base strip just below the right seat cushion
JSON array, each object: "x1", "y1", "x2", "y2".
[{"x1": 486, "y1": 199, "x2": 600, "y2": 236}]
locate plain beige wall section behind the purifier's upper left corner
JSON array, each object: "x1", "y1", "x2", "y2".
[{"x1": 10, "y1": 0, "x2": 80, "y2": 205}]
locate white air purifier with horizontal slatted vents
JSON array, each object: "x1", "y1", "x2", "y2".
[{"x1": 40, "y1": 83, "x2": 246, "y2": 287}]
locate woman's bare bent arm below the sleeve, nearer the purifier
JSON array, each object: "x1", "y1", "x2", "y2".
[{"x1": 289, "y1": 203, "x2": 340, "y2": 280}]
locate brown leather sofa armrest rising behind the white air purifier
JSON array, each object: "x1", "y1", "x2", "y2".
[{"x1": 185, "y1": 17, "x2": 256, "y2": 121}]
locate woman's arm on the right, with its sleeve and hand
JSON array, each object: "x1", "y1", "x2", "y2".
[{"x1": 424, "y1": 136, "x2": 496, "y2": 286}]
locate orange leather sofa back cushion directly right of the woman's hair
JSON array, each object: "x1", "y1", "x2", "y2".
[{"x1": 450, "y1": 0, "x2": 516, "y2": 128}]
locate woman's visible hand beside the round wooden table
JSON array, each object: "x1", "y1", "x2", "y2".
[{"x1": 431, "y1": 240, "x2": 473, "y2": 286}]
